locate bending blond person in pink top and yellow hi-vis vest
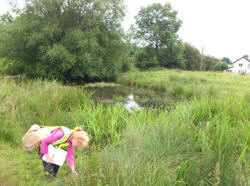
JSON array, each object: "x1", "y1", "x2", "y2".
[{"x1": 40, "y1": 127, "x2": 89, "y2": 177}]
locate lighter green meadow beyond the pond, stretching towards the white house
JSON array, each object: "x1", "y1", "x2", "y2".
[{"x1": 117, "y1": 70, "x2": 250, "y2": 99}]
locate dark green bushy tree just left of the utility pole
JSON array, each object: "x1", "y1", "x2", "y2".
[{"x1": 183, "y1": 43, "x2": 201, "y2": 70}]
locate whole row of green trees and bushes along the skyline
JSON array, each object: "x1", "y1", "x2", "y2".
[{"x1": 0, "y1": 0, "x2": 230, "y2": 81}]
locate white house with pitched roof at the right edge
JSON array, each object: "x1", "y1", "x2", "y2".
[{"x1": 224, "y1": 55, "x2": 250, "y2": 75}]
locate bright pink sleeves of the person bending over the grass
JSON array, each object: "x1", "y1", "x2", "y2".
[{"x1": 40, "y1": 128, "x2": 74, "y2": 167}]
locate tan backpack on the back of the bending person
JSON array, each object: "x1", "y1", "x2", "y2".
[{"x1": 22, "y1": 124, "x2": 42, "y2": 153}]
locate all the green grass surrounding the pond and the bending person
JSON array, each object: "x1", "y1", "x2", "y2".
[{"x1": 0, "y1": 71, "x2": 250, "y2": 186}]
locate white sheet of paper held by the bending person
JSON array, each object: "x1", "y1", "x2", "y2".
[{"x1": 42, "y1": 144, "x2": 67, "y2": 166}]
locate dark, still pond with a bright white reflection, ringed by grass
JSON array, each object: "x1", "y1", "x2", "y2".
[{"x1": 84, "y1": 85, "x2": 176, "y2": 110}]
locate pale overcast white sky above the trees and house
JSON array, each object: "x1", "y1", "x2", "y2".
[{"x1": 0, "y1": 0, "x2": 250, "y2": 61}]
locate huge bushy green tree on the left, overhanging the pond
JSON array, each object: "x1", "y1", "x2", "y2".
[{"x1": 0, "y1": 0, "x2": 125, "y2": 81}]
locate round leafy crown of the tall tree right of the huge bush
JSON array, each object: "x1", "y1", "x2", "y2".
[{"x1": 136, "y1": 3, "x2": 181, "y2": 49}]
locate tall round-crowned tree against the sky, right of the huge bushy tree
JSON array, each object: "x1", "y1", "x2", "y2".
[{"x1": 135, "y1": 3, "x2": 184, "y2": 68}]
